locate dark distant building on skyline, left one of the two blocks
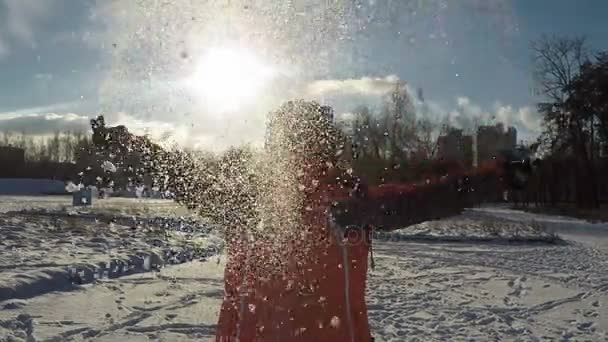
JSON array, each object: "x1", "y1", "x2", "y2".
[{"x1": 437, "y1": 129, "x2": 474, "y2": 168}]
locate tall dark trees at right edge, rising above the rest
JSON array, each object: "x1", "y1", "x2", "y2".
[{"x1": 517, "y1": 36, "x2": 608, "y2": 208}]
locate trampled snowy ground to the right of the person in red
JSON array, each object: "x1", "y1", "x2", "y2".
[{"x1": 368, "y1": 208, "x2": 608, "y2": 341}]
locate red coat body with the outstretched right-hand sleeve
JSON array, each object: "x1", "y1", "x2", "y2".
[{"x1": 216, "y1": 160, "x2": 504, "y2": 341}]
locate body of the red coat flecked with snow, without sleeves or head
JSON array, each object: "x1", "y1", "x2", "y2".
[{"x1": 216, "y1": 179, "x2": 371, "y2": 342}]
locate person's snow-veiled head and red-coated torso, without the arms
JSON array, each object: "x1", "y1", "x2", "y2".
[{"x1": 216, "y1": 102, "x2": 372, "y2": 341}]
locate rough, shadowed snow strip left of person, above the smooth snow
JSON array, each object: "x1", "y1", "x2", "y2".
[{"x1": 0, "y1": 210, "x2": 222, "y2": 302}]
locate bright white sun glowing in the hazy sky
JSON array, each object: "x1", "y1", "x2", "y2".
[{"x1": 188, "y1": 46, "x2": 274, "y2": 112}]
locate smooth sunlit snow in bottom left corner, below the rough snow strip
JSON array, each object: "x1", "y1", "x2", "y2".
[{"x1": 0, "y1": 259, "x2": 224, "y2": 342}]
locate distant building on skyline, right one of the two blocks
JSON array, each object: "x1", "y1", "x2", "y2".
[{"x1": 475, "y1": 123, "x2": 517, "y2": 165}]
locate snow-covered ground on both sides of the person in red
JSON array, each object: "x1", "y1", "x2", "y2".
[{"x1": 0, "y1": 197, "x2": 608, "y2": 341}]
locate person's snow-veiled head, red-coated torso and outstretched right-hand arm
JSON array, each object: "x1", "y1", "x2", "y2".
[{"x1": 216, "y1": 101, "x2": 528, "y2": 341}]
